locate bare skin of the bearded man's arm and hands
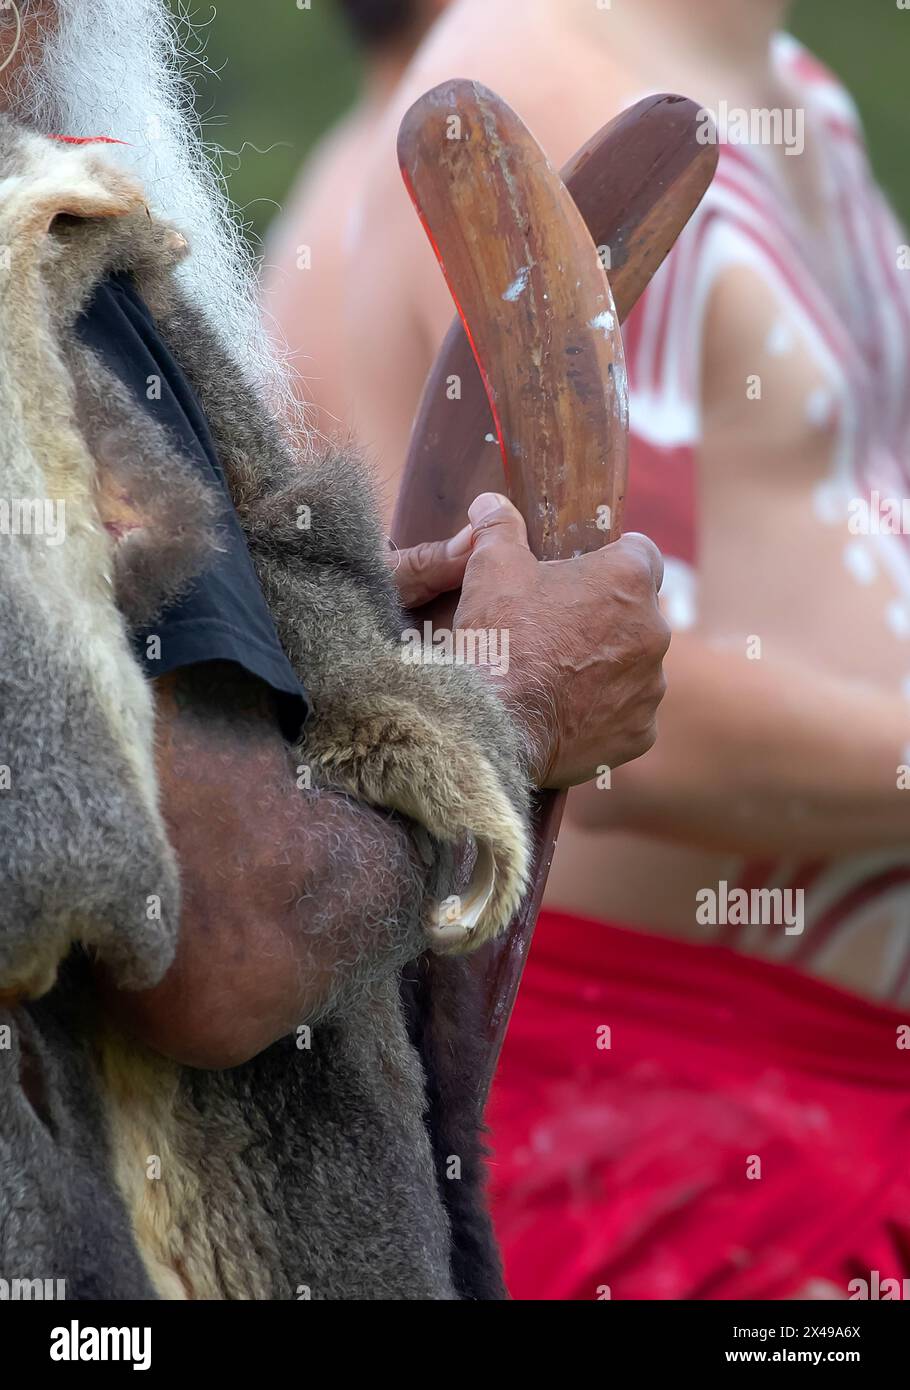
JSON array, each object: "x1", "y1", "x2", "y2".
[{"x1": 104, "y1": 493, "x2": 668, "y2": 1068}]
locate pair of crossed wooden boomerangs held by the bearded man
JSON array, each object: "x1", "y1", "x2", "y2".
[{"x1": 393, "y1": 81, "x2": 717, "y2": 1094}]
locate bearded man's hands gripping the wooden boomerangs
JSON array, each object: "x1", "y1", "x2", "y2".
[{"x1": 396, "y1": 492, "x2": 670, "y2": 787}]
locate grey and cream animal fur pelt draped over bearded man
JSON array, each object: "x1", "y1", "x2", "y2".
[{"x1": 0, "y1": 118, "x2": 528, "y2": 1298}]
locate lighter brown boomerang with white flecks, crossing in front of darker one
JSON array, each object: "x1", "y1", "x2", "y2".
[{"x1": 399, "y1": 82, "x2": 628, "y2": 560}]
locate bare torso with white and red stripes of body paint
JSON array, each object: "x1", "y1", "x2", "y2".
[{"x1": 550, "y1": 38, "x2": 910, "y2": 999}]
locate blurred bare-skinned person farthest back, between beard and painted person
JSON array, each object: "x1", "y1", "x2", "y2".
[{"x1": 263, "y1": 0, "x2": 449, "y2": 434}]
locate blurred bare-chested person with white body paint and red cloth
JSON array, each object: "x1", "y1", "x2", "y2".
[{"x1": 302, "y1": 0, "x2": 910, "y2": 1298}]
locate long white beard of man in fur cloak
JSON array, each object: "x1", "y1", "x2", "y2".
[{"x1": 10, "y1": 0, "x2": 301, "y2": 430}]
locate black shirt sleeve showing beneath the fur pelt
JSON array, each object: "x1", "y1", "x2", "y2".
[{"x1": 76, "y1": 275, "x2": 310, "y2": 741}]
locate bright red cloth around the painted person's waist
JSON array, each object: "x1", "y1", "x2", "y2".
[{"x1": 488, "y1": 913, "x2": 910, "y2": 1300}]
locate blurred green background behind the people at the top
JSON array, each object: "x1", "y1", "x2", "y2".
[{"x1": 183, "y1": 0, "x2": 910, "y2": 244}]
